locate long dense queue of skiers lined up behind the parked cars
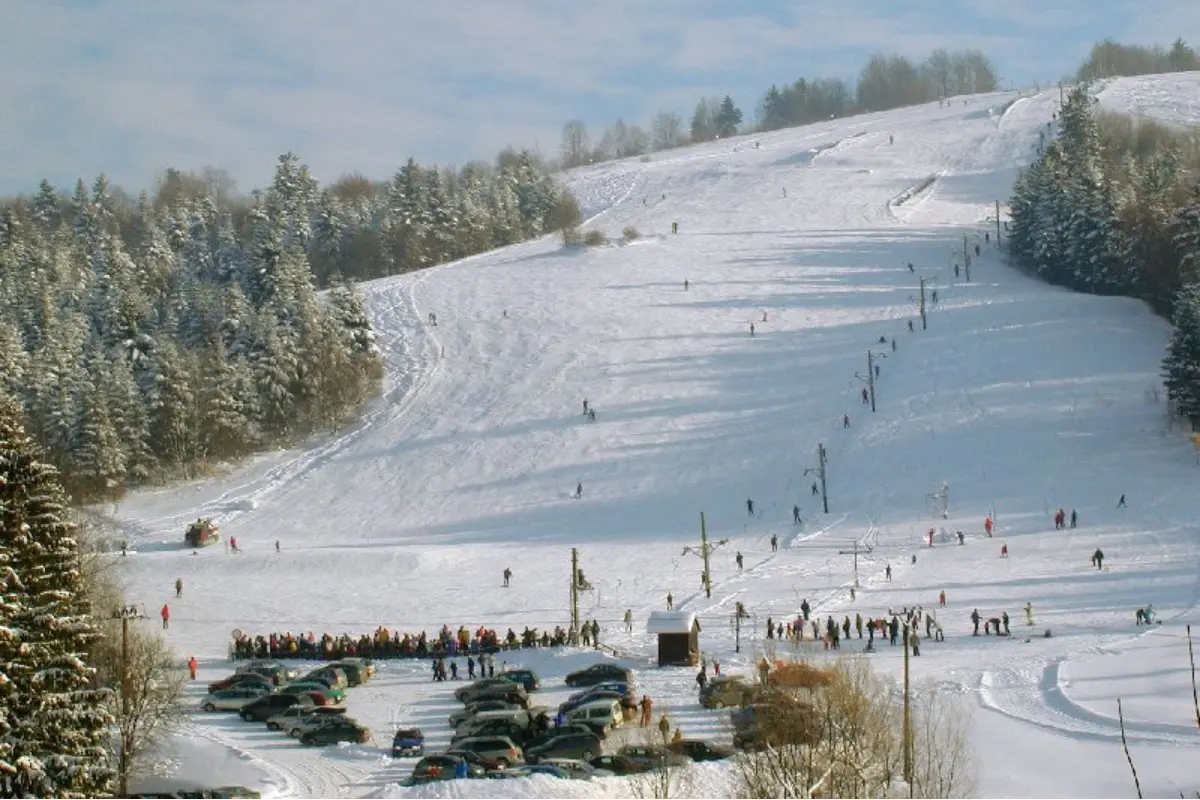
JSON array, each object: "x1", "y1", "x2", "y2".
[{"x1": 229, "y1": 626, "x2": 578, "y2": 661}]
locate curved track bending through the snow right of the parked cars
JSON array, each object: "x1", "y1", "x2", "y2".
[{"x1": 979, "y1": 662, "x2": 1196, "y2": 745}]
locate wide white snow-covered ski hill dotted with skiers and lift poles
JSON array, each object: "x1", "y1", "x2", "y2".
[{"x1": 115, "y1": 77, "x2": 1200, "y2": 796}]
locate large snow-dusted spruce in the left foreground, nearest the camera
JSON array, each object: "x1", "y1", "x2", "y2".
[{"x1": 0, "y1": 399, "x2": 113, "y2": 798}]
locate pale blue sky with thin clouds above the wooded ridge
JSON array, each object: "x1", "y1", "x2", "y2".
[{"x1": 0, "y1": 0, "x2": 1200, "y2": 194}]
